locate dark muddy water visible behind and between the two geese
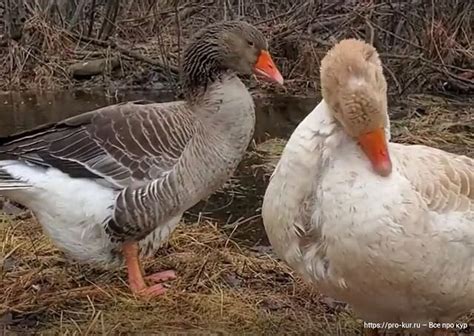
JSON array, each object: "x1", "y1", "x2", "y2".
[{"x1": 0, "y1": 90, "x2": 317, "y2": 246}]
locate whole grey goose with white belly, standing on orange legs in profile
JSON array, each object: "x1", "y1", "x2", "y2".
[{"x1": 0, "y1": 21, "x2": 283, "y2": 297}]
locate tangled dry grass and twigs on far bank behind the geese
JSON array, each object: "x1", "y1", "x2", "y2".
[{"x1": 0, "y1": 0, "x2": 474, "y2": 95}]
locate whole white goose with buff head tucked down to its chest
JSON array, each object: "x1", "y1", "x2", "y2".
[{"x1": 262, "y1": 39, "x2": 474, "y2": 334}]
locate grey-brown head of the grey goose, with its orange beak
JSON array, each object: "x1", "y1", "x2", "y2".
[{"x1": 183, "y1": 21, "x2": 283, "y2": 93}]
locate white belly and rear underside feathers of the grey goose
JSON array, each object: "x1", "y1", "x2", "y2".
[{"x1": 0, "y1": 161, "x2": 181, "y2": 268}]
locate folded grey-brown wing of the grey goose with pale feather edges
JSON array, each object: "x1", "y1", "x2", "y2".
[{"x1": 0, "y1": 102, "x2": 195, "y2": 189}]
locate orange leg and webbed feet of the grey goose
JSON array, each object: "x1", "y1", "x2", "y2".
[{"x1": 122, "y1": 242, "x2": 176, "y2": 297}]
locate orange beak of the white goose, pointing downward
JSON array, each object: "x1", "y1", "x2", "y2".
[{"x1": 358, "y1": 128, "x2": 392, "y2": 176}]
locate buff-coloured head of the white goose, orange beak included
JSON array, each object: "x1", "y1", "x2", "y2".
[{"x1": 321, "y1": 39, "x2": 392, "y2": 176}]
